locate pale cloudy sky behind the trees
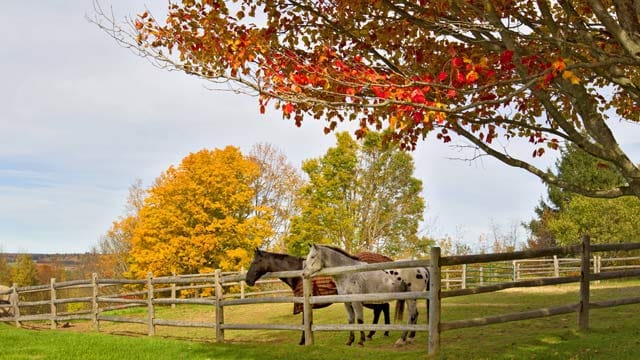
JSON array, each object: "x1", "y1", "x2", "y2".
[{"x1": 0, "y1": 0, "x2": 640, "y2": 253}]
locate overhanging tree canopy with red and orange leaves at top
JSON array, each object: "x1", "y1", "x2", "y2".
[{"x1": 94, "y1": 0, "x2": 640, "y2": 198}]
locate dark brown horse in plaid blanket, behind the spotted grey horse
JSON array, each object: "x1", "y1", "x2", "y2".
[{"x1": 245, "y1": 249, "x2": 393, "y2": 345}]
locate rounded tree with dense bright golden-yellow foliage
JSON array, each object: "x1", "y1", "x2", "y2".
[{"x1": 130, "y1": 146, "x2": 271, "y2": 277}]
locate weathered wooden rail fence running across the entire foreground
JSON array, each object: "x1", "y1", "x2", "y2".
[{"x1": 0, "y1": 237, "x2": 640, "y2": 354}]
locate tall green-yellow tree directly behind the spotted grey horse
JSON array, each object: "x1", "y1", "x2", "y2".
[{"x1": 288, "y1": 132, "x2": 426, "y2": 255}]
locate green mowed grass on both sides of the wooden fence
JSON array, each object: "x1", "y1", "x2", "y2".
[{"x1": 0, "y1": 281, "x2": 640, "y2": 360}]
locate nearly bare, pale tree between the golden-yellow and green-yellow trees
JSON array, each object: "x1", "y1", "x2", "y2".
[{"x1": 248, "y1": 143, "x2": 304, "y2": 251}]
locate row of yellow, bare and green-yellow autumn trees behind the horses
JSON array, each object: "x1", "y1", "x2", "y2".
[{"x1": 94, "y1": 132, "x2": 431, "y2": 277}]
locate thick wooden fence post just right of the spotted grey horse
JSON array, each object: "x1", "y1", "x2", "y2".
[{"x1": 429, "y1": 247, "x2": 440, "y2": 356}]
